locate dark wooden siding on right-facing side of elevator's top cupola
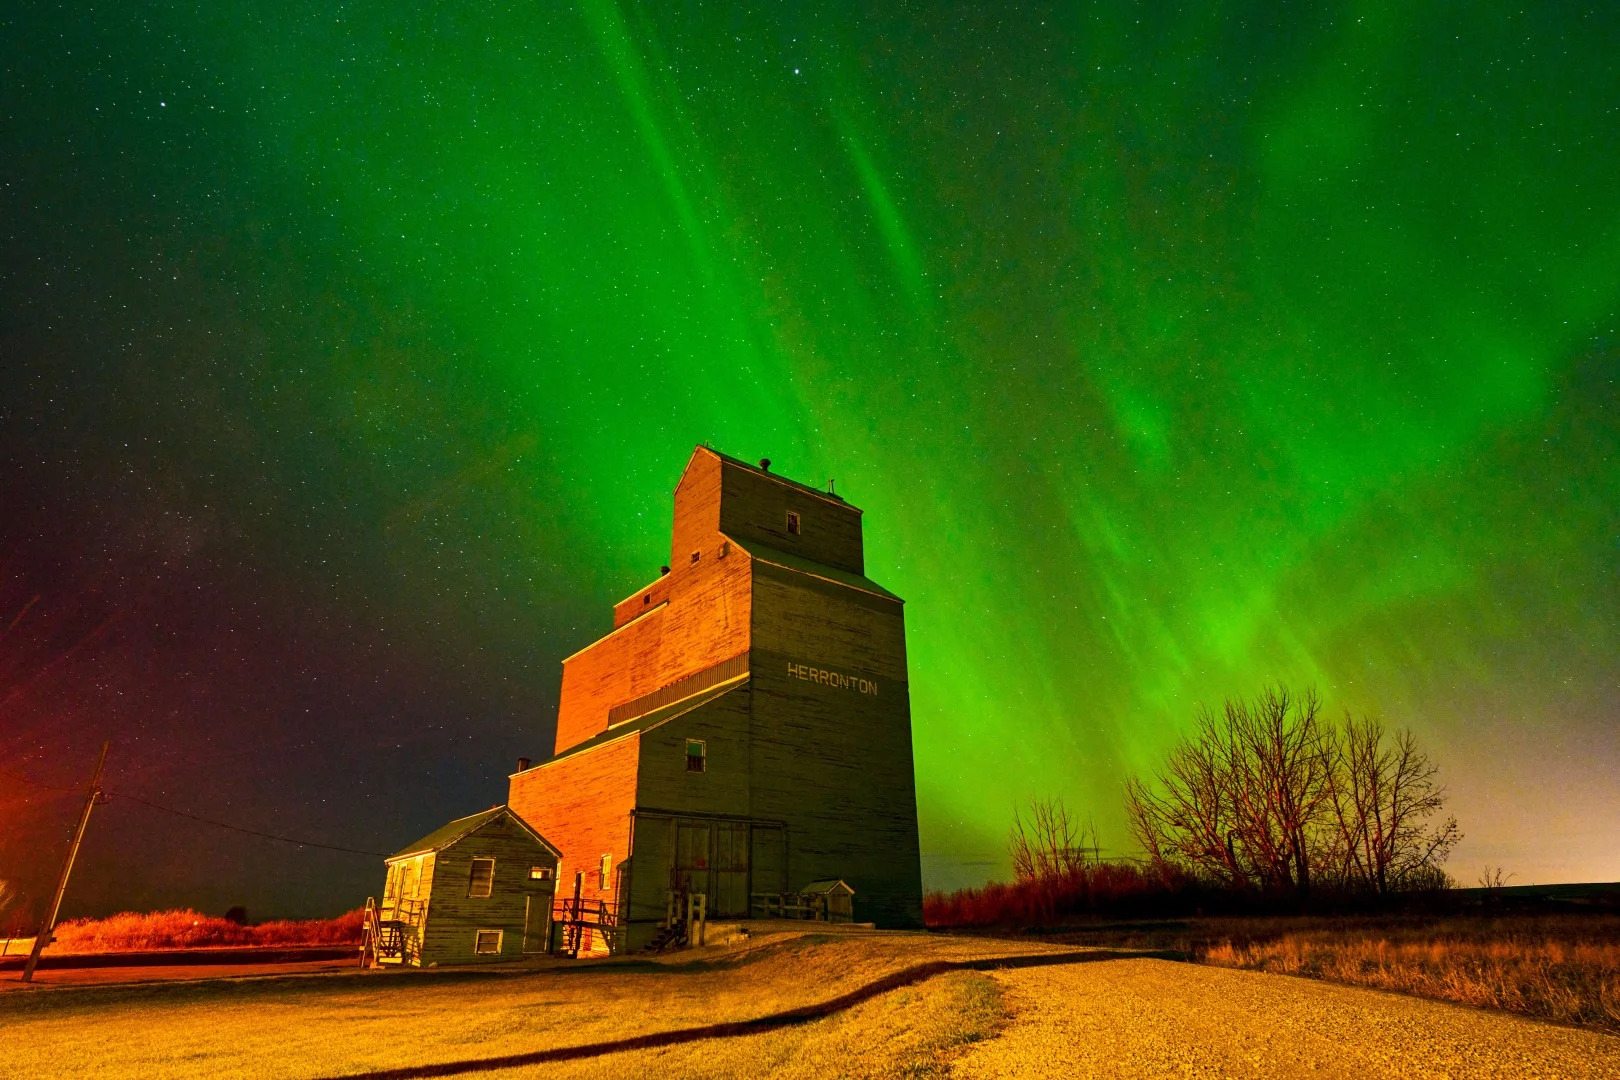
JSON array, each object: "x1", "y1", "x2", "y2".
[{"x1": 719, "y1": 461, "x2": 865, "y2": 573}]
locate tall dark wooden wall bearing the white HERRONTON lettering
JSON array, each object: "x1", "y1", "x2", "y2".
[{"x1": 750, "y1": 563, "x2": 922, "y2": 926}]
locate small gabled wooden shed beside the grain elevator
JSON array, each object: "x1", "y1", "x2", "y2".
[{"x1": 379, "y1": 805, "x2": 561, "y2": 967}]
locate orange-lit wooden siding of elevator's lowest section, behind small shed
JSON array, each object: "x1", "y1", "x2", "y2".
[{"x1": 507, "y1": 733, "x2": 642, "y2": 904}]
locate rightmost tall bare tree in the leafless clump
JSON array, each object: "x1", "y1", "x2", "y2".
[{"x1": 1328, "y1": 714, "x2": 1463, "y2": 894}]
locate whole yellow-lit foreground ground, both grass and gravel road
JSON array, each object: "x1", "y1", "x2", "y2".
[{"x1": 0, "y1": 933, "x2": 1620, "y2": 1080}]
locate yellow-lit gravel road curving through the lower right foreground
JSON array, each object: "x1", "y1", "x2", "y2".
[{"x1": 951, "y1": 960, "x2": 1620, "y2": 1080}]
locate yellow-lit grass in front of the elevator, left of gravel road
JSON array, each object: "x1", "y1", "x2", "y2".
[{"x1": 0, "y1": 934, "x2": 1063, "y2": 1080}]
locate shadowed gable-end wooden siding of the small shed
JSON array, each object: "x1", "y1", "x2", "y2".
[{"x1": 421, "y1": 814, "x2": 556, "y2": 967}]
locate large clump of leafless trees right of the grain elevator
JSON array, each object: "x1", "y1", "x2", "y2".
[{"x1": 1126, "y1": 687, "x2": 1461, "y2": 899}]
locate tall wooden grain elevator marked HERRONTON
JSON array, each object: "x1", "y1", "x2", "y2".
[{"x1": 507, "y1": 447, "x2": 922, "y2": 949}]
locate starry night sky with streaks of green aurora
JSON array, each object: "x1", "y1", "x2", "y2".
[{"x1": 0, "y1": 0, "x2": 1620, "y2": 923}]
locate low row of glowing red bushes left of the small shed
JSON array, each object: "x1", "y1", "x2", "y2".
[{"x1": 52, "y1": 908, "x2": 361, "y2": 952}]
